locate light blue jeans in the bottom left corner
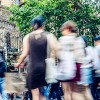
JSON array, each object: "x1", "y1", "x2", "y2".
[{"x1": 0, "y1": 78, "x2": 9, "y2": 100}]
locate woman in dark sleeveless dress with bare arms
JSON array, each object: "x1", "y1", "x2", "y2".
[{"x1": 15, "y1": 16, "x2": 57, "y2": 100}]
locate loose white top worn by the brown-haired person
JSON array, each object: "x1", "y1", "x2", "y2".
[{"x1": 59, "y1": 33, "x2": 85, "y2": 63}]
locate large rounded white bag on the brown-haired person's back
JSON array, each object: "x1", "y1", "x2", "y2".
[{"x1": 57, "y1": 52, "x2": 76, "y2": 81}]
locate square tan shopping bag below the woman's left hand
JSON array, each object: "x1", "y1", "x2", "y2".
[{"x1": 5, "y1": 69, "x2": 27, "y2": 93}]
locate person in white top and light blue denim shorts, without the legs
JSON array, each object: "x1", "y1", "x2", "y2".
[{"x1": 81, "y1": 36, "x2": 100, "y2": 85}]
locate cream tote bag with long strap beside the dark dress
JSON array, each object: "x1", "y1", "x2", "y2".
[{"x1": 45, "y1": 35, "x2": 58, "y2": 84}]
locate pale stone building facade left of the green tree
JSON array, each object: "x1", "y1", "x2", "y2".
[{"x1": 0, "y1": 5, "x2": 23, "y2": 51}]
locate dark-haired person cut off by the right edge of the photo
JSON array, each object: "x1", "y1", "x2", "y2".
[{"x1": 90, "y1": 36, "x2": 100, "y2": 100}]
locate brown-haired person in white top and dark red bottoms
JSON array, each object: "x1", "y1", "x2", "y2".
[{"x1": 59, "y1": 21, "x2": 85, "y2": 100}]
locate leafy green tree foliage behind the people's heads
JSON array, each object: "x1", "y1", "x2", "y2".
[{"x1": 10, "y1": 0, "x2": 100, "y2": 44}]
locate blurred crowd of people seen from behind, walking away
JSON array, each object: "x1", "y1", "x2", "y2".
[{"x1": 0, "y1": 16, "x2": 100, "y2": 100}]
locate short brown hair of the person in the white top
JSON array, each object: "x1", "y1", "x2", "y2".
[{"x1": 60, "y1": 21, "x2": 78, "y2": 33}]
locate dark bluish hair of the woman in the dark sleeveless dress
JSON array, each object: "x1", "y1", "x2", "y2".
[{"x1": 31, "y1": 16, "x2": 45, "y2": 30}]
